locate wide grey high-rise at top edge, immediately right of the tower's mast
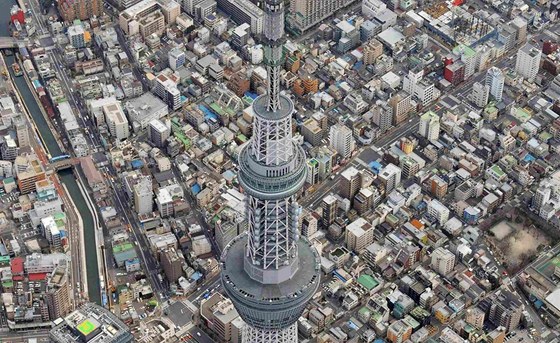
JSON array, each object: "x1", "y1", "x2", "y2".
[{"x1": 287, "y1": 0, "x2": 356, "y2": 33}]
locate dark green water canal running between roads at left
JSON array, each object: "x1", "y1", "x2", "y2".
[{"x1": 0, "y1": 0, "x2": 101, "y2": 304}]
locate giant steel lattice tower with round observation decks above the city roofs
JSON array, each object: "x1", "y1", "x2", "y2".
[{"x1": 221, "y1": 0, "x2": 320, "y2": 343}]
